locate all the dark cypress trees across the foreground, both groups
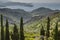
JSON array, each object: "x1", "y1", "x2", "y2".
[{"x1": 1, "y1": 15, "x2": 60, "y2": 40}]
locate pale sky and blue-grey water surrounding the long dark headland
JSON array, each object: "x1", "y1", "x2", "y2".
[{"x1": 0, "y1": 0, "x2": 60, "y2": 11}]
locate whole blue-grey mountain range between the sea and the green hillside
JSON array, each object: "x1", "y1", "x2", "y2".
[{"x1": 0, "y1": 7, "x2": 60, "y2": 24}]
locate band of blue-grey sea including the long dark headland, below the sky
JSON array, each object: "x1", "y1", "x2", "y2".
[{"x1": 0, "y1": 2, "x2": 60, "y2": 12}]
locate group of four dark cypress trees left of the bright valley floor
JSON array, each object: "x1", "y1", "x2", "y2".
[{"x1": 1, "y1": 15, "x2": 25, "y2": 40}]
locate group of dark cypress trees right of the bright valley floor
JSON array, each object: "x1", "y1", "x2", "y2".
[{"x1": 40, "y1": 17, "x2": 60, "y2": 40}]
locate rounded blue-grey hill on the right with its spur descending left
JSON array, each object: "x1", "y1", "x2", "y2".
[{"x1": 26, "y1": 7, "x2": 60, "y2": 23}]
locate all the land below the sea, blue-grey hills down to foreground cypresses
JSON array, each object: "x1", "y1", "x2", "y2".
[{"x1": 0, "y1": 7, "x2": 60, "y2": 40}]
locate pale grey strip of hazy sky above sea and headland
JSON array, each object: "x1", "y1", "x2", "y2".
[{"x1": 0, "y1": 0, "x2": 60, "y2": 3}]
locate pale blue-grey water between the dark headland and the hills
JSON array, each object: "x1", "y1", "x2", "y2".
[{"x1": 0, "y1": 3, "x2": 60, "y2": 11}]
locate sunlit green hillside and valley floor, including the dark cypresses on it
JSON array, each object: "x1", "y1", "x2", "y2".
[{"x1": 0, "y1": 12, "x2": 60, "y2": 40}]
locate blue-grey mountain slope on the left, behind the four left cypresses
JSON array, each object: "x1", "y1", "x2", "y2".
[{"x1": 0, "y1": 8, "x2": 31, "y2": 23}]
